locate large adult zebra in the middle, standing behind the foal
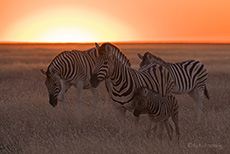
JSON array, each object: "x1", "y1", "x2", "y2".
[{"x1": 90, "y1": 43, "x2": 174, "y2": 125}]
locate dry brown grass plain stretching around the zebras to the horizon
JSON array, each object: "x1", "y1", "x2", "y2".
[{"x1": 0, "y1": 44, "x2": 230, "y2": 154}]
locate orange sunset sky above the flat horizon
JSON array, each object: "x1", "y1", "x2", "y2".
[{"x1": 0, "y1": 0, "x2": 230, "y2": 43}]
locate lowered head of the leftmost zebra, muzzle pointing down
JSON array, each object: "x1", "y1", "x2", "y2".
[{"x1": 40, "y1": 69, "x2": 61, "y2": 107}]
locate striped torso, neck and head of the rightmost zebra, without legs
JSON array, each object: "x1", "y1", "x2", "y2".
[{"x1": 140, "y1": 52, "x2": 208, "y2": 93}]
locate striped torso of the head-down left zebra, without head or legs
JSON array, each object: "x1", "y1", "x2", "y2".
[{"x1": 47, "y1": 48, "x2": 97, "y2": 85}]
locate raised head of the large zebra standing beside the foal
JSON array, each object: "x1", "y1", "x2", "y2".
[{"x1": 90, "y1": 44, "x2": 114, "y2": 88}]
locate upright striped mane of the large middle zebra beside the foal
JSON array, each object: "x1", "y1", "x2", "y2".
[{"x1": 98, "y1": 43, "x2": 131, "y2": 66}]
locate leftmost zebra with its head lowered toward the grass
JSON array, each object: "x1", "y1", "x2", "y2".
[{"x1": 40, "y1": 48, "x2": 111, "y2": 109}]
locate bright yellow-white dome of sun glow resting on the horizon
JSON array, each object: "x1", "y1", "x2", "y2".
[{"x1": 4, "y1": 8, "x2": 136, "y2": 42}]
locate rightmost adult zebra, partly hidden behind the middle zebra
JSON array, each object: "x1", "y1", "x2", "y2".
[{"x1": 138, "y1": 52, "x2": 209, "y2": 122}]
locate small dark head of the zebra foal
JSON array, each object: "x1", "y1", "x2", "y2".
[{"x1": 133, "y1": 87, "x2": 148, "y2": 117}]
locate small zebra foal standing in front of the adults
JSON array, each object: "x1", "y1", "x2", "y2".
[{"x1": 133, "y1": 87, "x2": 180, "y2": 142}]
